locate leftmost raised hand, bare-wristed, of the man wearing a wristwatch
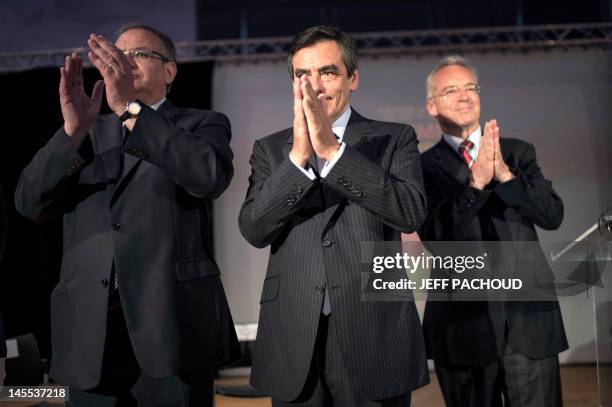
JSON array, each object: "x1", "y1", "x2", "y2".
[{"x1": 59, "y1": 53, "x2": 104, "y2": 145}]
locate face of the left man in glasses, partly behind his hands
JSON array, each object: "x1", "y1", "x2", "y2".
[{"x1": 115, "y1": 28, "x2": 176, "y2": 105}]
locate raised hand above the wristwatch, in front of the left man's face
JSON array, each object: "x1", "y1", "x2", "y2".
[{"x1": 87, "y1": 34, "x2": 136, "y2": 116}]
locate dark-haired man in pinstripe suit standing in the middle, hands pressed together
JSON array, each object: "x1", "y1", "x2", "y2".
[{"x1": 239, "y1": 26, "x2": 429, "y2": 407}]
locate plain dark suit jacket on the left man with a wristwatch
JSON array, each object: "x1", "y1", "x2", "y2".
[{"x1": 15, "y1": 101, "x2": 238, "y2": 389}]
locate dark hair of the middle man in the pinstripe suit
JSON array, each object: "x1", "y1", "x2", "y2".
[{"x1": 287, "y1": 25, "x2": 359, "y2": 78}]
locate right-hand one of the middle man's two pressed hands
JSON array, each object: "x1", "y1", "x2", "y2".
[{"x1": 300, "y1": 75, "x2": 340, "y2": 161}]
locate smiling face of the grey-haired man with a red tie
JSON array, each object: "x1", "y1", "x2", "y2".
[{"x1": 427, "y1": 65, "x2": 480, "y2": 132}]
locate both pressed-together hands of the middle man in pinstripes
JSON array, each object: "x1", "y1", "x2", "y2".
[{"x1": 289, "y1": 75, "x2": 340, "y2": 168}]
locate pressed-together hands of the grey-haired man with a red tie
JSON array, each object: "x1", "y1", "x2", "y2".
[{"x1": 470, "y1": 120, "x2": 514, "y2": 189}]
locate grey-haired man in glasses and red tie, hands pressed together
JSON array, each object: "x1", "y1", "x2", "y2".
[{"x1": 420, "y1": 56, "x2": 568, "y2": 407}]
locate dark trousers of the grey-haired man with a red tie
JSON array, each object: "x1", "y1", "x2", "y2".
[{"x1": 435, "y1": 346, "x2": 563, "y2": 407}]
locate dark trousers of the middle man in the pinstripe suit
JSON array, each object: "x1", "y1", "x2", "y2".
[{"x1": 272, "y1": 312, "x2": 411, "y2": 407}]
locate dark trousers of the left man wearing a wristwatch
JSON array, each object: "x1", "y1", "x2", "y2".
[{"x1": 68, "y1": 289, "x2": 214, "y2": 407}]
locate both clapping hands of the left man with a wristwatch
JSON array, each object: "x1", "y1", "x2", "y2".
[{"x1": 59, "y1": 34, "x2": 136, "y2": 144}]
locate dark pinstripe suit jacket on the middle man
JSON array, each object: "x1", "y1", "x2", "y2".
[{"x1": 239, "y1": 111, "x2": 429, "y2": 400}]
